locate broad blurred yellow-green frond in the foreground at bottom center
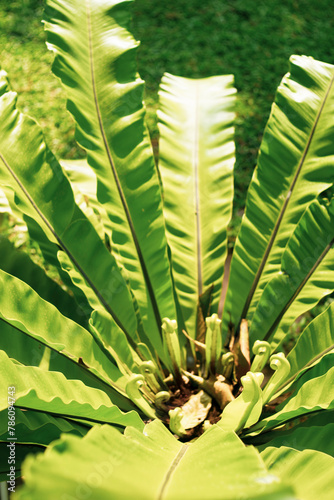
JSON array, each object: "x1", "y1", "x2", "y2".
[{"x1": 18, "y1": 421, "x2": 295, "y2": 500}]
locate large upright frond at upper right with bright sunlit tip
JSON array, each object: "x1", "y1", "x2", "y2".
[{"x1": 224, "y1": 56, "x2": 334, "y2": 338}]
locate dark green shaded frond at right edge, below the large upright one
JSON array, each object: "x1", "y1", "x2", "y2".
[{"x1": 249, "y1": 194, "x2": 334, "y2": 343}]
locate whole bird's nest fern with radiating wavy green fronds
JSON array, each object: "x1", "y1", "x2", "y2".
[{"x1": 0, "y1": 0, "x2": 334, "y2": 500}]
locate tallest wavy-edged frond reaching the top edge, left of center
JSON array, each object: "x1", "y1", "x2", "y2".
[{"x1": 45, "y1": 0, "x2": 176, "y2": 347}]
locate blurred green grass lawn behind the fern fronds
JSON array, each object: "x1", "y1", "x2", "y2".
[{"x1": 0, "y1": 0, "x2": 334, "y2": 214}]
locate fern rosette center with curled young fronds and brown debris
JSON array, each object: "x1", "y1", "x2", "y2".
[{"x1": 126, "y1": 314, "x2": 290, "y2": 441}]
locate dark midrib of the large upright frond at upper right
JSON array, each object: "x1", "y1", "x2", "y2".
[{"x1": 241, "y1": 74, "x2": 334, "y2": 318}]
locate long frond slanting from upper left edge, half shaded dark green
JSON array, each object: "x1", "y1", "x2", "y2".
[{"x1": 0, "y1": 76, "x2": 137, "y2": 341}]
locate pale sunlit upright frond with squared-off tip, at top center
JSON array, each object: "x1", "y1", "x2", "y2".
[{"x1": 158, "y1": 74, "x2": 236, "y2": 337}]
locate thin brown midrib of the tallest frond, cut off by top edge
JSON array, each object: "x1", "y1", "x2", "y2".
[{"x1": 86, "y1": 0, "x2": 162, "y2": 334}]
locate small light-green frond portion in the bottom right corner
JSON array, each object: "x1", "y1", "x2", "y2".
[{"x1": 261, "y1": 446, "x2": 334, "y2": 500}]
